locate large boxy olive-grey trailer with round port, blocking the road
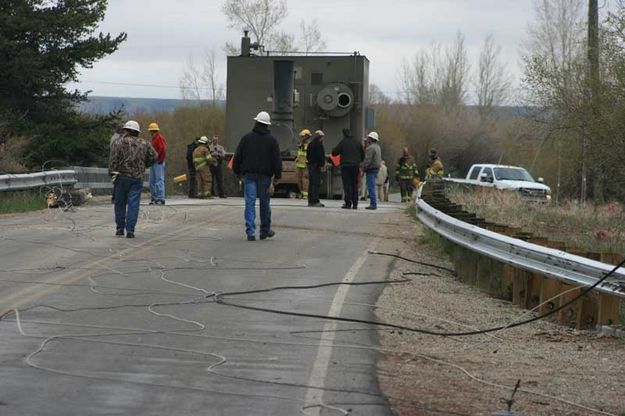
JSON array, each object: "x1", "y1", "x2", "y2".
[{"x1": 225, "y1": 33, "x2": 375, "y2": 198}]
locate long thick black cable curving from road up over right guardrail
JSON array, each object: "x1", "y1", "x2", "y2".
[{"x1": 216, "y1": 253, "x2": 625, "y2": 337}]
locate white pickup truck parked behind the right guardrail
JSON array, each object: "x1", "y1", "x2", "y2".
[{"x1": 445, "y1": 164, "x2": 551, "y2": 201}]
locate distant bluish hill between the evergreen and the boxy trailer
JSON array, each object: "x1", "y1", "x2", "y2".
[{"x1": 78, "y1": 96, "x2": 225, "y2": 115}]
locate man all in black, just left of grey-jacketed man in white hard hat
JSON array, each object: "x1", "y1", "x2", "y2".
[{"x1": 332, "y1": 128, "x2": 365, "y2": 209}]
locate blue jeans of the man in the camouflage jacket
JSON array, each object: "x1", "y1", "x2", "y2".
[{"x1": 114, "y1": 175, "x2": 143, "y2": 233}]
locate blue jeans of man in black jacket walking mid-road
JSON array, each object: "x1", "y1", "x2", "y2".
[{"x1": 243, "y1": 174, "x2": 271, "y2": 235}]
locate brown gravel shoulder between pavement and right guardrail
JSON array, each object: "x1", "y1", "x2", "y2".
[{"x1": 376, "y1": 214, "x2": 625, "y2": 416}]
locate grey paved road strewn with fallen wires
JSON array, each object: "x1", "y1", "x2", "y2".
[{"x1": 0, "y1": 198, "x2": 403, "y2": 416}]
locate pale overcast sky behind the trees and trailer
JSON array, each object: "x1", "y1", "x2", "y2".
[{"x1": 62, "y1": 0, "x2": 600, "y2": 102}]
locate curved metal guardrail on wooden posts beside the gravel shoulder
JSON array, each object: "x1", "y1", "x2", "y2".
[{"x1": 417, "y1": 190, "x2": 625, "y2": 298}]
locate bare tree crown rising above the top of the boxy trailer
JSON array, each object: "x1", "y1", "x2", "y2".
[{"x1": 221, "y1": 0, "x2": 288, "y2": 45}]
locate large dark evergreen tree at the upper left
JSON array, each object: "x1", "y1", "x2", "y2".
[{"x1": 0, "y1": 0, "x2": 126, "y2": 164}]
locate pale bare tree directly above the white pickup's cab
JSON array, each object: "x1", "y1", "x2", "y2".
[{"x1": 475, "y1": 34, "x2": 510, "y2": 115}]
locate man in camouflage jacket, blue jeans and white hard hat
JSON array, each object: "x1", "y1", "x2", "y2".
[{"x1": 109, "y1": 120, "x2": 157, "y2": 238}]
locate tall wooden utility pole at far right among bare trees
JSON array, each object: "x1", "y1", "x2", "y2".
[{"x1": 580, "y1": 0, "x2": 599, "y2": 204}]
